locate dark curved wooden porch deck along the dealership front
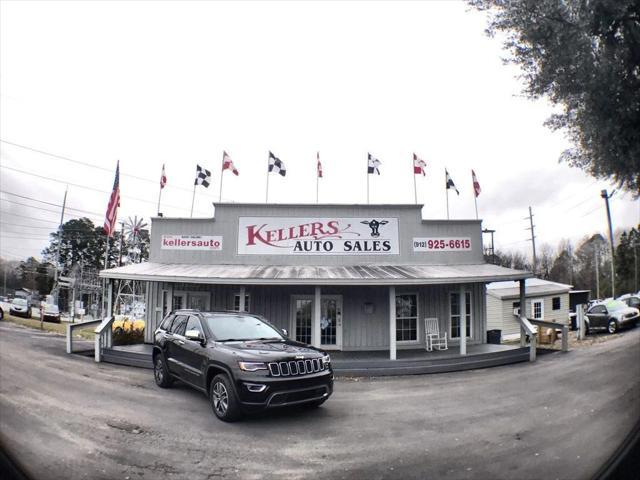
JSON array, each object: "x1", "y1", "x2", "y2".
[{"x1": 103, "y1": 344, "x2": 529, "y2": 377}]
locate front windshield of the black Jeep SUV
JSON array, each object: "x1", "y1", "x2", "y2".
[{"x1": 202, "y1": 313, "x2": 283, "y2": 342}]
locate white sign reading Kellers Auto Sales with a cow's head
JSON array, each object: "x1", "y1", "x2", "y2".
[{"x1": 238, "y1": 217, "x2": 400, "y2": 255}]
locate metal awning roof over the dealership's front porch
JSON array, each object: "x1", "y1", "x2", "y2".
[{"x1": 100, "y1": 262, "x2": 532, "y2": 285}]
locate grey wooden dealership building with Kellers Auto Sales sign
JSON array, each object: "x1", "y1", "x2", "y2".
[{"x1": 101, "y1": 203, "x2": 532, "y2": 359}]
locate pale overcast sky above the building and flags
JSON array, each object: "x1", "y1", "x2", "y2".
[{"x1": 0, "y1": 1, "x2": 640, "y2": 259}]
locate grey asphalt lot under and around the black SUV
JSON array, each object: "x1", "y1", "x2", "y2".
[{"x1": 0, "y1": 322, "x2": 640, "y2": 480}]
